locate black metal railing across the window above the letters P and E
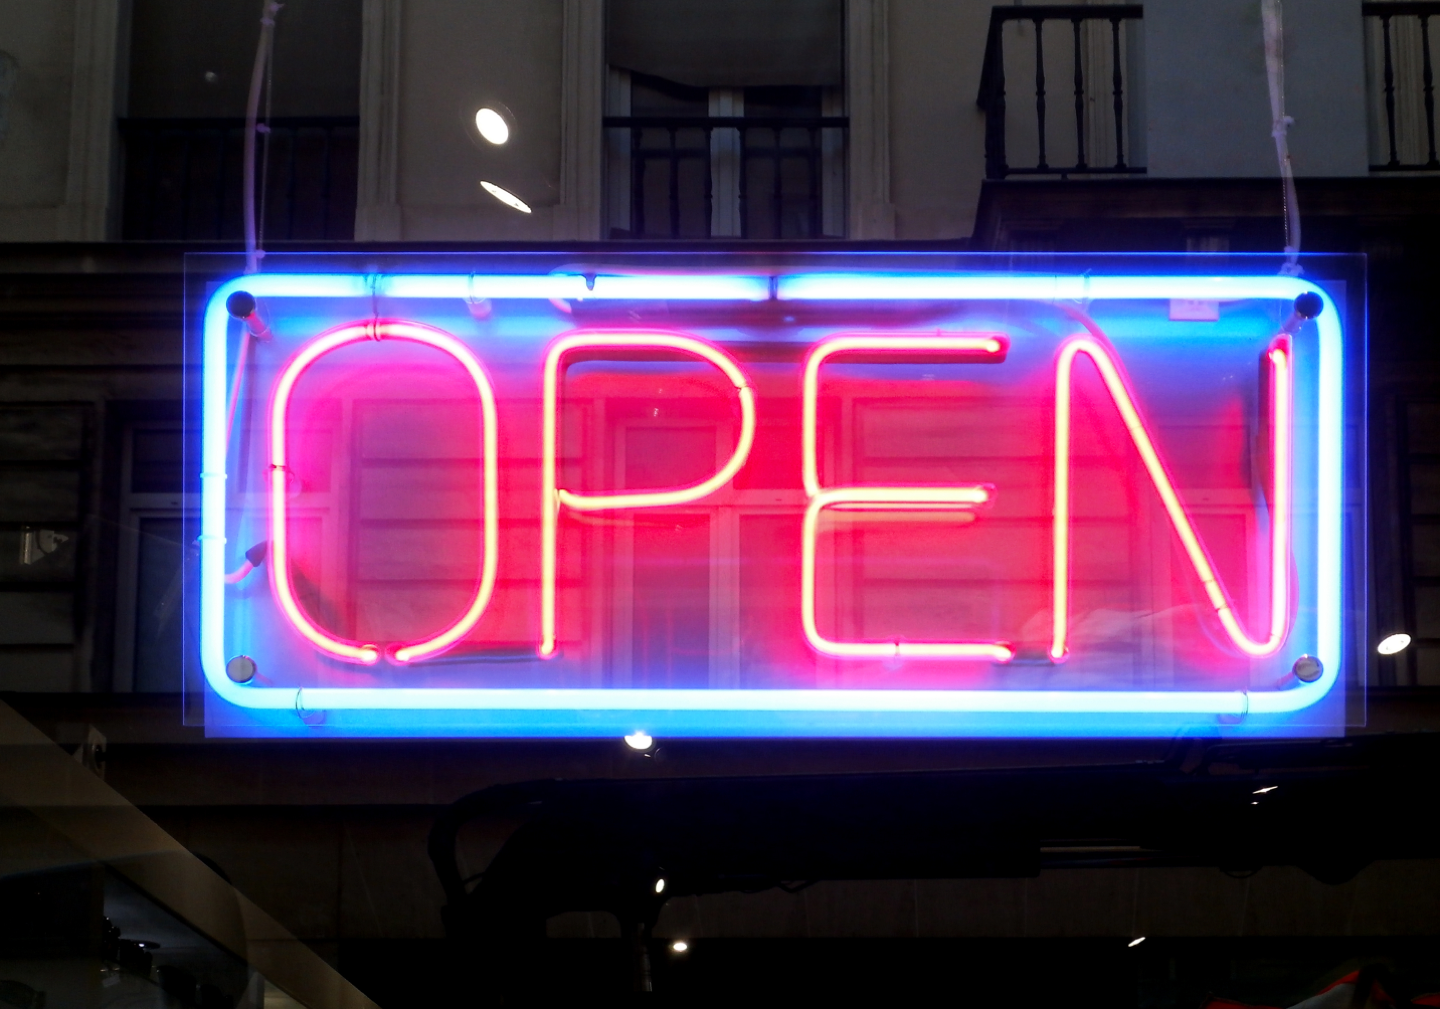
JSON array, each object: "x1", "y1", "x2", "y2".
[{"x1": 605, "y1": 115, "x2": 850, "y2": 239}]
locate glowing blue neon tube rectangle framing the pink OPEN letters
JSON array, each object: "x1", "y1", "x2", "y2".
[{"x1": 199, "y1": 272, "x2": 1344, "y2": 736}]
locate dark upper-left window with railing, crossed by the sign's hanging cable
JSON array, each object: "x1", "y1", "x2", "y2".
[{"x1": 120, "y1": 0, "x2": 360, "y2": 240}]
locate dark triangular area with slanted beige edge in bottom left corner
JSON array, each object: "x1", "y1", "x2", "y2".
[{"x1": 0, "y1": 705, "x2": 365, "y2": 1009}]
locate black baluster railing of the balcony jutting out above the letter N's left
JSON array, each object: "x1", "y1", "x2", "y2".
[{"x1": 976, "y1": 4, "x2": 1145, "y2": 178}]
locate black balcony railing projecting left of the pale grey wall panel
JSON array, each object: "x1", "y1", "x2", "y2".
[{"x1": 976, "y1": 4, "x2": 1145, "y2": 178}]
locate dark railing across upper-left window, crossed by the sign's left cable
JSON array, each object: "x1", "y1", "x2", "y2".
[{"x1": 120, "y1": 117, "x2": 360, "y2": 240}]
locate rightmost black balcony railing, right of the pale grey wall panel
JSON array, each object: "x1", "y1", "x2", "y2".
[{"x1": 1361, "y1": 0, "x2": 1440, "y2": 171}]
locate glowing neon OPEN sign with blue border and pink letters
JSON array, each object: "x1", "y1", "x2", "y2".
[{"x1": 197, "y1": 255, "x2": 1364, "y2": 737}]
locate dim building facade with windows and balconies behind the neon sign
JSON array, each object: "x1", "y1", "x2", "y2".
[{"x1": 0, "y1": 0, "x2": 1440, "y2": 997}]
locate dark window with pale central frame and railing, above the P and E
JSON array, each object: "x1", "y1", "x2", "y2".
[{"x1": 605, "y1": 0, "x2": 848, "y2": 239}]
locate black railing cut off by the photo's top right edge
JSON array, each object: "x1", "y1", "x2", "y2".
[{"x1": 1361, "y1": 0, "x2": 1440, "y2": 171}]
